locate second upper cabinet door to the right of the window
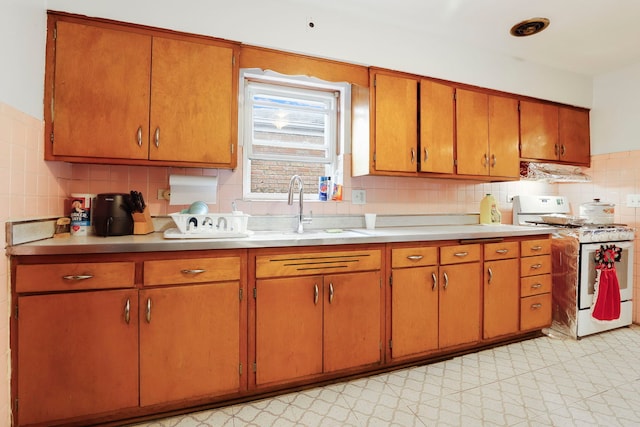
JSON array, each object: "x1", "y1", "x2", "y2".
[{"x1": 420, "y1": 79, "x2": 455, "y2": 173}]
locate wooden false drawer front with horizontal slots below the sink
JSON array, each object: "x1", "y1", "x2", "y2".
[{"x1": 256, "y1": 250, "x2": 381, "y2": 278}]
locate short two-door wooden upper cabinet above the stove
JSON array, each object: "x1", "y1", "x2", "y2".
[{"x1": 520, "y1": 101, "x2": 591, "y2": 166}]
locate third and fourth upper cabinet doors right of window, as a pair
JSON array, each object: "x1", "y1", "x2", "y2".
[{"x1": 456, "y1": 89, "x2": 520, "y2": 178}]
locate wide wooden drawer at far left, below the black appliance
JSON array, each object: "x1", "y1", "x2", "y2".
[{"x1": 16, "y1": 261, "x2": 136, "y2": 293}]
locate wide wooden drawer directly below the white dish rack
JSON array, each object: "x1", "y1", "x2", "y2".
[{"x1": 143, "y1": 256, "x2": 241, "y2": 286}]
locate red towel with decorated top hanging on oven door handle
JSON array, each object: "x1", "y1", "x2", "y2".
[{"x1": 591, "y1": 245, "x2": 622, "y2": 321}]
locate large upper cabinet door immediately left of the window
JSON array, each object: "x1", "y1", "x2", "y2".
[{"x1": 149, "y1": 37, "x2": 237, "y2": 165}]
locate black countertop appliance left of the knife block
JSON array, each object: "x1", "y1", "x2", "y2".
[{"x1": 91, "y1": 193, "x2": 133, "y2": 237}]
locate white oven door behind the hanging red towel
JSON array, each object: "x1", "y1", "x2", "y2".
[{"x1": 578, "y1": 241, "x2": 633, "y2": 310}]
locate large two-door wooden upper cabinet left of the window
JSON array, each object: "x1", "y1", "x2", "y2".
[{"x1": 45, "y1": 15, "x2": 238, "y2": 168}]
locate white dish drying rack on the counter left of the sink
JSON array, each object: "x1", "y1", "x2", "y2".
[{"x1": 164, "y1": 212, "x2": 252, "y2": 239}]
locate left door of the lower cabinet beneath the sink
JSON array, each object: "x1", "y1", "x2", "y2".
[{"x1": 256, "y1": 276, "x2": 323, "y2": 386}]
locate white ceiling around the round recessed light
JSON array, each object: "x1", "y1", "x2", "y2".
[{"x1": 300, "y1": 0, "x2": 640, "y2": 76}]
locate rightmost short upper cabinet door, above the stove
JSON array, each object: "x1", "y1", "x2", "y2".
[{"x1": 559, "y1": 107, "x2": 591, "y2": 166}]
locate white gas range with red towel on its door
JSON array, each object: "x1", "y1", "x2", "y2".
[{"x1": 513, "y1": 195, "x2": 635, "y2": 338}]
